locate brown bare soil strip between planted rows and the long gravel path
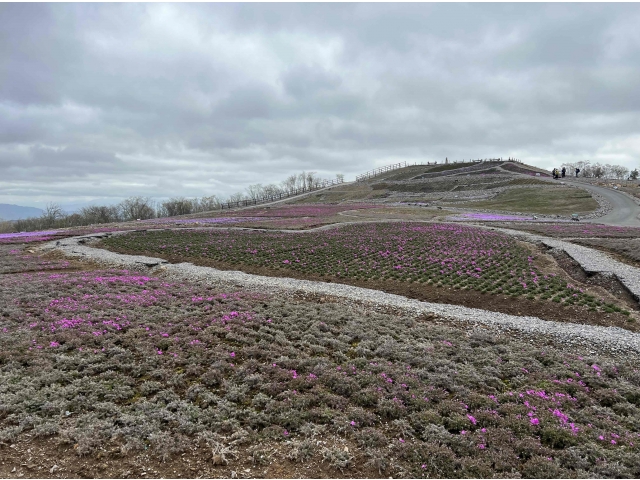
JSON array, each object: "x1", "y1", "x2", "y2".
[{"x1": 102, "y1": 249, "x2": 640, "y2": 332}]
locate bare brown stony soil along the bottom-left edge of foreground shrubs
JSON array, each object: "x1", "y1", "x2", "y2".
[{"x1": 0, "y1": 437, "x2": 384, "y2": 478}]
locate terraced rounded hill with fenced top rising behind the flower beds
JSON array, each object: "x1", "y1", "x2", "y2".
[{"x1": 292, "y1": 160, "x2": 598, "y2": 215}]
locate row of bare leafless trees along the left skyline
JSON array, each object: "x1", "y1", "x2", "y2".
[{"x1": 0, "y1": 172, "x2": 344, "y2": 233}]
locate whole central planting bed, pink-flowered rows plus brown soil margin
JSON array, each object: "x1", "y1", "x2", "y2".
[{"x1": 102, "y1": 222, "x2": 638, "y2": 330}]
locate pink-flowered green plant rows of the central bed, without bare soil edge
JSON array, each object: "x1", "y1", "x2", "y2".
[{"x1": 104, "y1": 222, "x2": 621, "y2": 312}]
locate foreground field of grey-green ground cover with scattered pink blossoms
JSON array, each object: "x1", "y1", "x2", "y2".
[{"x1": 0, "y1": 249, "x2": 640, "y2": 478}]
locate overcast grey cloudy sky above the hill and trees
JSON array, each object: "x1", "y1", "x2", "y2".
[{"x1": 0, "y1": 3, "x2": 640, "y2": 206}]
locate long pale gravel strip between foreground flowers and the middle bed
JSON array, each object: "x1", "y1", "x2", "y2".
[{"x1": 41, "y1": 232, "x2": 640, "y2": 354}]
